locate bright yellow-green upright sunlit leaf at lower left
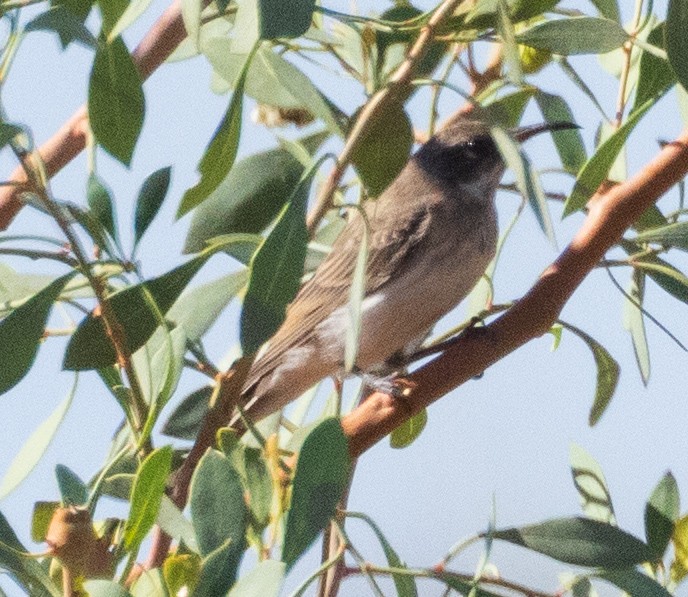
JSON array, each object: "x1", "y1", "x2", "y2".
[{"x1": 124, "y1": 446, "x2": 172, "y2": 554}]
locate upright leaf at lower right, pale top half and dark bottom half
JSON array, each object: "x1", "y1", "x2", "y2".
[{"x1": 645, "y1": 473, "x2": 681, "y2": 561}]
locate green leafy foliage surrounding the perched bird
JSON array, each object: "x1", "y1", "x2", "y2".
[{"x1": 0, "y1": 0, "x2": 688, "y2": 597}]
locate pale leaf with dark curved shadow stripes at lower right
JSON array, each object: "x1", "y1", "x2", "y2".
[{"x1": 569, "y1": 444, "x2": 616, "y2": 525}]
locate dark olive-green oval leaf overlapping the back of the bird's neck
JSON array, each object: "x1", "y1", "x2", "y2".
[{"x1": 351, "y1": 102, "x2": 413, "y2": 197}]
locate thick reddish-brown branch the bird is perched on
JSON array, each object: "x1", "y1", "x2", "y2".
[{"x1": 342, "y1": 129, "x2": 688, "y2": 457}]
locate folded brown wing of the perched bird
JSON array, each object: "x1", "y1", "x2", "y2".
[{"x1": 245, "y1": 205, "x2": 430, "y2": 390}]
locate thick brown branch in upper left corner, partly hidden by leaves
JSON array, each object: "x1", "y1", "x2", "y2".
[{"x1": 0, "y1": 0, "x2": 186, "y2": 230}]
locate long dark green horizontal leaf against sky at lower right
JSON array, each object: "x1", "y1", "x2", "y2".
[{"x1": 492, "y1": 517, "x2": 653, "y2": 568}]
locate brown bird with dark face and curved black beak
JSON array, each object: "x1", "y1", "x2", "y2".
[{"x1": 230, "y1": 115, "x2": 576, "y2": 427}]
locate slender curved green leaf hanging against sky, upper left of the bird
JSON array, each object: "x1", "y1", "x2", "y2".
[{"x1": 177, "y1": 54, "x2": 253, "y2": 218}]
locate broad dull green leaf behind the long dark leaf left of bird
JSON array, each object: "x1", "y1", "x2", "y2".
[{"x1": 184, "y1": 135, "x2": 324, "y2": 253}]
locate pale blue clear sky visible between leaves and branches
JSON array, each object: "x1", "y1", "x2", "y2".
[{"x1": 0, "y1": 0, "x2": 688, "y2": 595}]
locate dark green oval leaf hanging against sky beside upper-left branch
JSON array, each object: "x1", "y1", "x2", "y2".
[{"x1": 88, "y1": 37, "x2": 145, "y2": 166}]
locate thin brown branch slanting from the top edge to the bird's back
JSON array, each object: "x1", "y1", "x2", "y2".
[{"x1": 308, "y1": 0, "x2": 463, "y2": 234}]
